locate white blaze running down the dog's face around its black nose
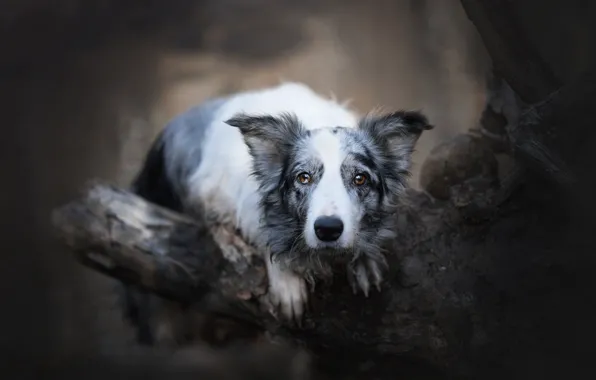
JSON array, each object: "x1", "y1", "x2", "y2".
[{"x1": 305, "y1": 129, "x2": 355, "y2": 247}]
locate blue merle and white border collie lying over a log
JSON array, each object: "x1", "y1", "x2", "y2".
[{"x1": 121, "y1": 82, "x2": 433, "y2": 343}]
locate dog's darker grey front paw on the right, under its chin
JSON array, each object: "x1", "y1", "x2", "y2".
[{"x1": 348, "y1": 256, "x2": 387, "y2": 297}]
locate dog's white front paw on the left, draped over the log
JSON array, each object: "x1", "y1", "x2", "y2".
[{"x1": 269, "y1": 271, "x2": 308, "y2": 323}]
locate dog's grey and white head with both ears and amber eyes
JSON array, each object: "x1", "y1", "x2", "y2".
[{"x1": 227, "y1": 111, "x2": 432, "y2": 272}]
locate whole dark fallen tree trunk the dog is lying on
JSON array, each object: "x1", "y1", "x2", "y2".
[{"x1": 53, "y1": 62, "x2": 591, "y2": 375}]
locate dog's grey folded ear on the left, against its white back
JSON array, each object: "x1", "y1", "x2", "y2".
[{"x1": 226, "y1": 114, "x2": 304, "y2": 188}]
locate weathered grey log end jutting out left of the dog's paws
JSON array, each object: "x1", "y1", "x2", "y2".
[{"x1": 52, "y1": 184, "x2": 266, "y2": 320}]
